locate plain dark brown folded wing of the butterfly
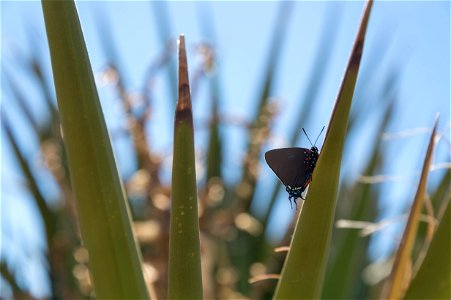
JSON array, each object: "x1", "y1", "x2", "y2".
[{"x1": 265, "y1": 147, "x2": 310, "y2": 187}]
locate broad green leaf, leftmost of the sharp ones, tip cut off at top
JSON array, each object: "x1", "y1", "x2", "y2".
[{"x1": 42, "y1": 0, "x2": 149, "y2": 299}]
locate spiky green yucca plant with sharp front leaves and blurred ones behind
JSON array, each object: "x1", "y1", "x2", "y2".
[{"x1": 0, "y1": 0, "x2": 450, "y2": 299}]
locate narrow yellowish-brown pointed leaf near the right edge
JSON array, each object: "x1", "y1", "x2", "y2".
[{"x1": 382, "y1": 117, "x2": 442, "y2": 299}]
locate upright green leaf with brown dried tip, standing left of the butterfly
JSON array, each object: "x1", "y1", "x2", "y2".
[{"x1": 168, "y1": 35, "x2": 202, "y2": 299}]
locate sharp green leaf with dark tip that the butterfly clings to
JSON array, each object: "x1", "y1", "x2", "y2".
[{"x1": 275, "y1": 1, "x2": 372, "y2": 299}]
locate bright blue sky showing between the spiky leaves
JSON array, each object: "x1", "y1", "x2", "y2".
[{"x1": 0, "y1": 1, "x2": 450, "y2": 293}]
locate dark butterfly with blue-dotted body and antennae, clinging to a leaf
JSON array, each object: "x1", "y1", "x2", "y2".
[{"x1": 265, "y1": 127, "x2": 324, "y2": 206}]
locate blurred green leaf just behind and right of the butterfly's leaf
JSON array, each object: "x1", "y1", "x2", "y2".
[{"x1": 322, "y1": 102, "x2": 393, "y2": 299}]
